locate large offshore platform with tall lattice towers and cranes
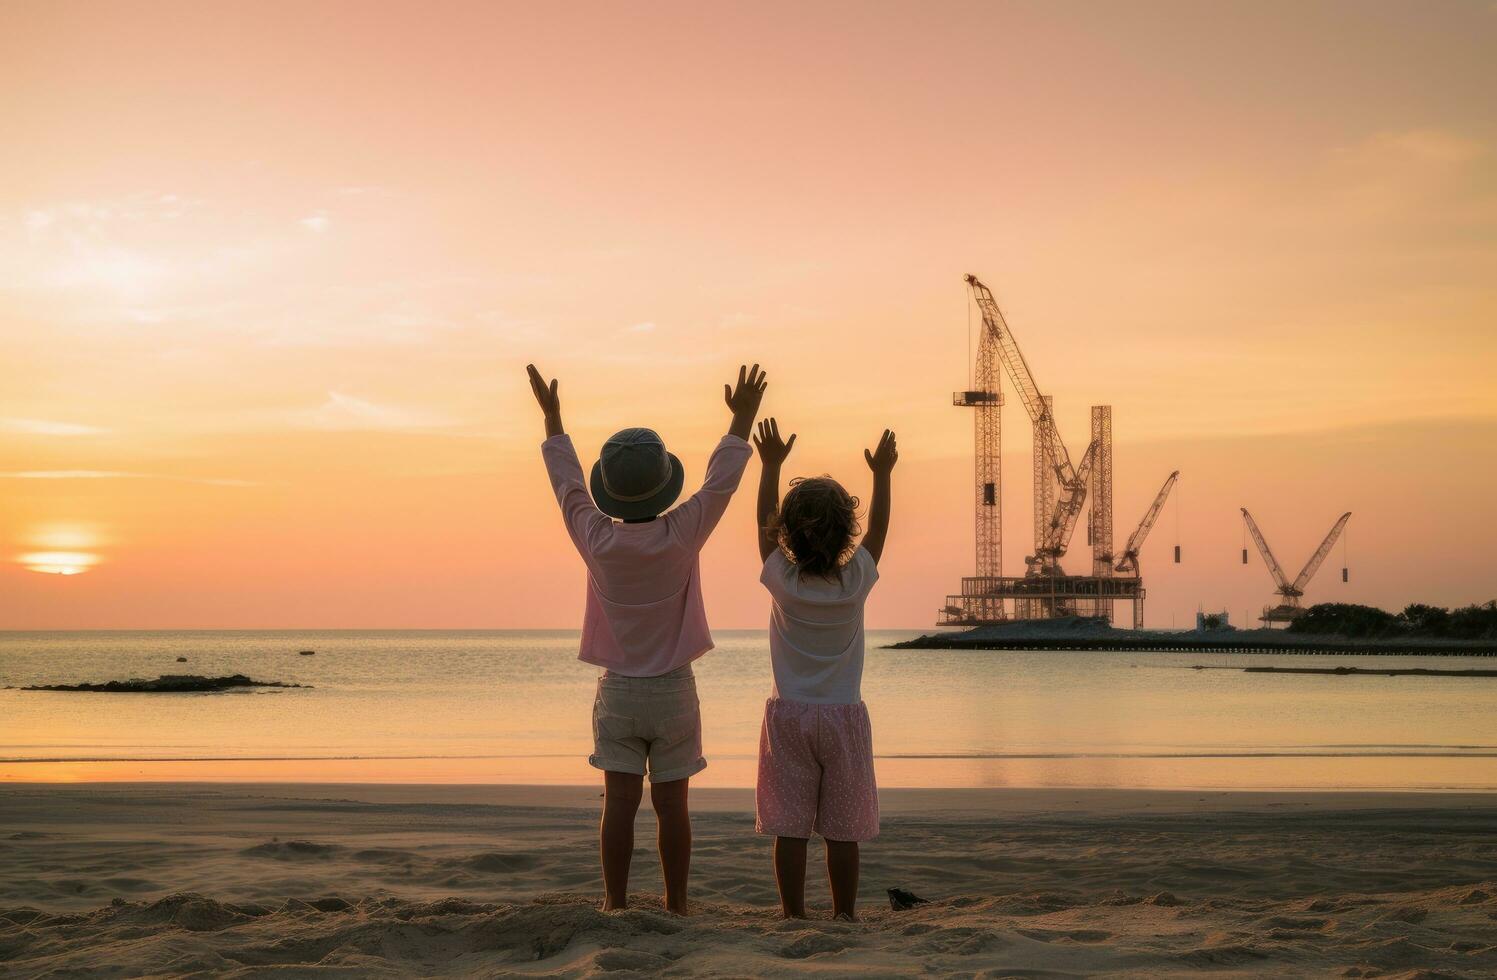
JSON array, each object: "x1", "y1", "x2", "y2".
[{"x1": 940, "y1": 275, "x2": 1180, "y2": 628}]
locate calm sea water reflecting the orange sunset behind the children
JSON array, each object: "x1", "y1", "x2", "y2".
[{"x1": 0, "y1": 630, "x2": 1497, "y2": 790}]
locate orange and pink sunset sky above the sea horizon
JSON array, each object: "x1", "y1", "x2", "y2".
[{"x1": 0, "y1": 1, "x2": 1497, "y2": 628}]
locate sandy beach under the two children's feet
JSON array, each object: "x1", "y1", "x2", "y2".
[{"x1": 0, "y1": 784, "x2": 1497, "y2": 977}]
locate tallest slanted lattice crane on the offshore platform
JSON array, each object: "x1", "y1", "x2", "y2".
[{"x1": 957, "y1": 274, "x2": 1091, "y2": 575}]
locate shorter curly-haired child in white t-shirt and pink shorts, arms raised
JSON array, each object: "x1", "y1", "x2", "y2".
[{"x1": 754, "y1": 419, "x2": 900, "y2": 920}]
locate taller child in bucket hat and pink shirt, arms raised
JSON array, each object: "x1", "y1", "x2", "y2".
[{"x1": 527, "y1": 364, "x2": 765, "y2": 914}]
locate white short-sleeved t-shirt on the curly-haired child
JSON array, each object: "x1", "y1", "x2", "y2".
[{"x1": 759, "y1": 548, "x2": 879, "y2": 705}]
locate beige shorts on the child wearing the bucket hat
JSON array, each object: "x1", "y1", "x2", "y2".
[{"x1": 587, "y1": 664, "x2": 707, "y2": 783}]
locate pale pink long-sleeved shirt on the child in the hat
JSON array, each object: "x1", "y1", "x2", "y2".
[{"x1": 540, "y1": 434, "x2": 753, "y2": 678}]
